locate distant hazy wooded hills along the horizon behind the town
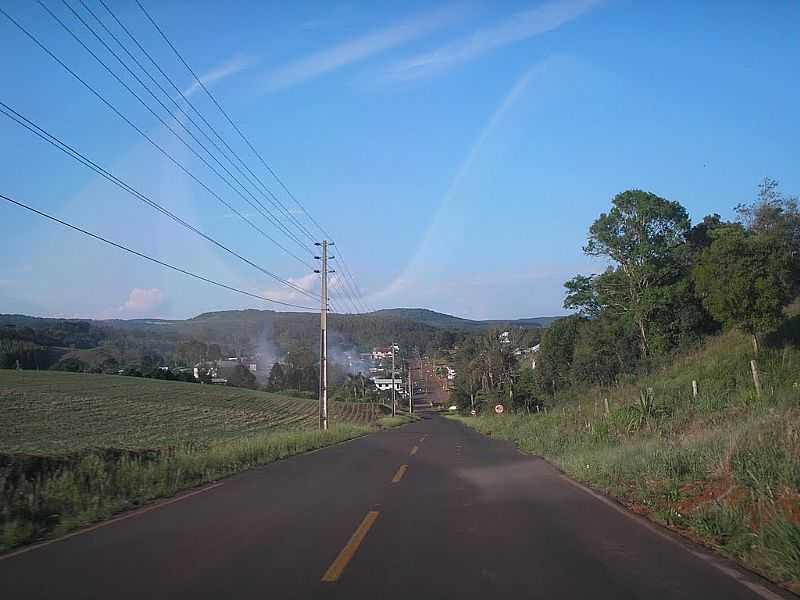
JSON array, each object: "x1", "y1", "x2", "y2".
[{"x1": 0, "y1": 308, "x2": 557, "y2": 372}]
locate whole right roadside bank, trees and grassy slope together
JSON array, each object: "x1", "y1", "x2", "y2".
[{"x1": 453, "y1": 179, "x2": 800, "y2": 589}]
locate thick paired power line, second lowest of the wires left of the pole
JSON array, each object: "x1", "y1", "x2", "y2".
[{"x1": 0, "y1": 100, "x2": 317, "y2": 300}]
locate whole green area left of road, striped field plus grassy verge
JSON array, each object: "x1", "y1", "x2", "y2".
[{"x1": 0, "y1": 370, "x2": 398, "y2": 551}]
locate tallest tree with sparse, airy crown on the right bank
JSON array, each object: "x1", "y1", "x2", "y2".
[{"x1": 583, "y1": 190, "x2": 689, "y2": 356}]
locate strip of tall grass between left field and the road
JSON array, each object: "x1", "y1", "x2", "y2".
[{"x1": 0, "y1": 423, "x2": 368, "y2": 551}]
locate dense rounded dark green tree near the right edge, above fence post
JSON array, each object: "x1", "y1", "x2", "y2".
[{"x1": 692, "y1": 225, "x2": 793, "y2": 352}]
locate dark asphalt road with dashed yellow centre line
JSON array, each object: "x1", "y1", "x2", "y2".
[{"x1": 0, "y1": 399, "x2": 790, "y2": 600}]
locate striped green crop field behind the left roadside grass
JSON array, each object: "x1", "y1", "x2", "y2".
[{"x1": 0, "y1": 370, "x2": 380, "y2": 454}]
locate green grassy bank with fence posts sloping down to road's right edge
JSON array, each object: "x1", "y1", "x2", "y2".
[{"x1": 455, "y1": 333, "x2": 800, "y2": 589}]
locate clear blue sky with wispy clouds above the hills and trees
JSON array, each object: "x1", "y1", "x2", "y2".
[{"x1": 0, "y1": 0, "x2": 800, "y2": 318}]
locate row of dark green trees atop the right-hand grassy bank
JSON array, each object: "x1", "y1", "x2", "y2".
[{"x1": 455, "y1": 179, "x2": 800, "y2": 410}]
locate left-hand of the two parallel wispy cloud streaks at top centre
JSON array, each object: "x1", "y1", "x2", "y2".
[{"x1": 266, "y1": 10, "x2": 458, "y2": 91}]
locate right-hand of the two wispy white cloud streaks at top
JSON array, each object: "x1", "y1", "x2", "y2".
[{"x1": 386, "y1": 0, "x2": 601, "y2": 81}]
